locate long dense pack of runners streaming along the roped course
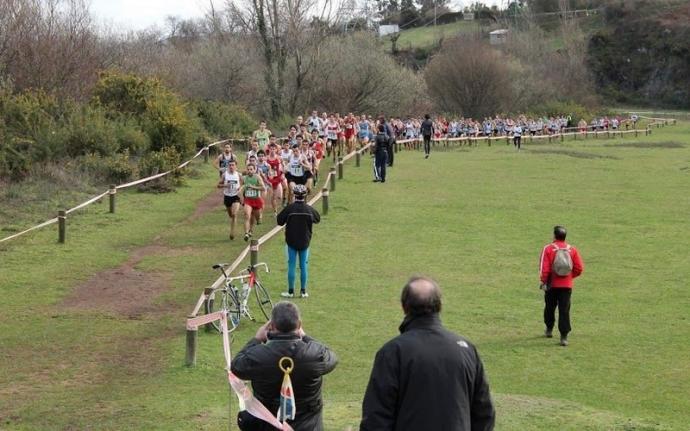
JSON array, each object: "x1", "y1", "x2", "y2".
[{"x1": 215, "y1": 111, "x2": 636, "y2": 241}]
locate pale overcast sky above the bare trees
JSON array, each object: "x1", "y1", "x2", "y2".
[{"x1": 91, "y1": 0, "x2": 500, "y2": 31}]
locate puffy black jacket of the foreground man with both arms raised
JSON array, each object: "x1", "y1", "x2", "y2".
[{"x1": 231, "y1": 334, "x2": 338, "y2": 431}]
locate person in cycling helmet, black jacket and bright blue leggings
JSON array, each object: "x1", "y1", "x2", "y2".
[{"x1": 276, "y1": 184, "x2": 321, "y2": 298}]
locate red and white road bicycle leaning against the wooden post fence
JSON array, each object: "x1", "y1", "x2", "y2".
[{"x1": 204, "y1": 262, "x2": 273, "y2": 332}]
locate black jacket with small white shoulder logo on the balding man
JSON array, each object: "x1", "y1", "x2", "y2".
[{"x1": 359, "y1": 315, "x2": 495, "y2": 431}]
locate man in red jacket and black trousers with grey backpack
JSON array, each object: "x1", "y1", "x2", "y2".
[{"x1": 539, "y1": 226, "x2": 584, "y2": 347}]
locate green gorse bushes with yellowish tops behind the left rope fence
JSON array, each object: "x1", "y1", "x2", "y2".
[{"x1": 0, "y1": 72, "x2": 256, "y2": 188}]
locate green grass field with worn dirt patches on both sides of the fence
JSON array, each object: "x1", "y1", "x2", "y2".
[{"x1": 0, "y1": 123, "x2": 690, "y2": 430}]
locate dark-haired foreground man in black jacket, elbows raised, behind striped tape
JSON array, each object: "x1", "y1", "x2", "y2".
[{"x1": 231, "y1": 302, "x2": 338, "y2": 431}]
